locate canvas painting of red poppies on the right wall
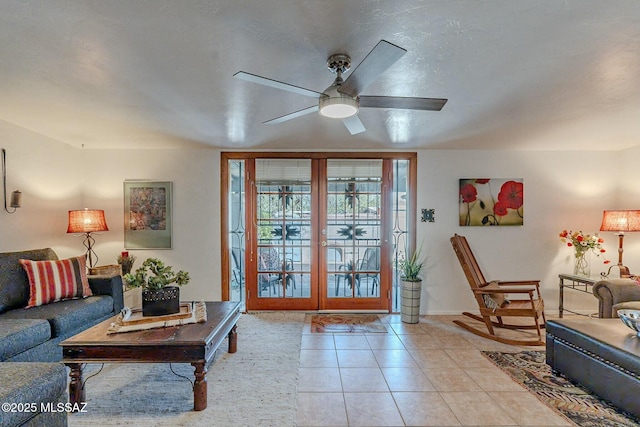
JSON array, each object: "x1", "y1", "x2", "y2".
[{"x1": 458, "y1": 178, "x2": 524, "y2": 226}]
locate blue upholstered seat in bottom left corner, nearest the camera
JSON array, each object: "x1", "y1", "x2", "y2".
[{"x1": 0, "y1": 362, "x2": 67, "y2": 426}]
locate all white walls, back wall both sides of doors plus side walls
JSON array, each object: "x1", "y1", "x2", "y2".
[{"x1": 0, "y1": 122, "x2": 640, "y2": 314}]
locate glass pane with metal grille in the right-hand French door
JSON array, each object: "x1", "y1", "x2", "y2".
[{"x1": 321, "y1": 159, "x2": 388, "y2": 309}]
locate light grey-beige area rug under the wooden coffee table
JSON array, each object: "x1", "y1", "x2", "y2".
[{"x1": 69, "y1": 313, "x2": 305, "y2": 427}]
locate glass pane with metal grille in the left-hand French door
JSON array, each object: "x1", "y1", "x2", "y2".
[{"x1": 249, "y1": 159, "x2": 317, "y2": 309}]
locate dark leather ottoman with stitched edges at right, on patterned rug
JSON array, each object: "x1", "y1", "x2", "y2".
[{"x1": 546, "y1": 319, "x2": 640, "y2": 417}]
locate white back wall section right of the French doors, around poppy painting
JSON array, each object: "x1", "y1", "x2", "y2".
[{"x1": 417, "y1": 151, "x2": 618, "y2": 314}]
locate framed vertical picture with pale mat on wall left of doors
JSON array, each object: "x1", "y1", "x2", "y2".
[{"x1": 123, "y1": 180, "x2": 173, "y2": 250}]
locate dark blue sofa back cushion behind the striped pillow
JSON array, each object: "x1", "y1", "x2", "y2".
[{"x1": 0, "y1": 248, "x2": 58, "y2": 313}]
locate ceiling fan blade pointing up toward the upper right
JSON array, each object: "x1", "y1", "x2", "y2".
[{"x1": 338, "y1": 40, "x2": 407, "y2": 96}]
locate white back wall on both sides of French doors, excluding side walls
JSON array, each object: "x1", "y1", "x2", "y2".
[{"x1": 84, "y1": 150, "x2": 619, "y2": 314}]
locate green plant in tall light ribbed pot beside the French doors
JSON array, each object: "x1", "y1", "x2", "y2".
[{"x1": 399, "y1": 247, "x2": 425, "y2": 323}]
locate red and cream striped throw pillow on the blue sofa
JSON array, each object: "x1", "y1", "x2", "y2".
[{"x1": 19, "y1": 256, "x2": 93, "y2": 308}]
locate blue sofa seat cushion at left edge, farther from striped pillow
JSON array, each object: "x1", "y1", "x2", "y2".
[{"x1": 0, "y1": 316, "x2": 51, "y2": 361}]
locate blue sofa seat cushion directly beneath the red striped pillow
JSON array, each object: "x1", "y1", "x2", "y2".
[{"x1": 2, "y1": 295, "x2": 113, "y2": 338}]
